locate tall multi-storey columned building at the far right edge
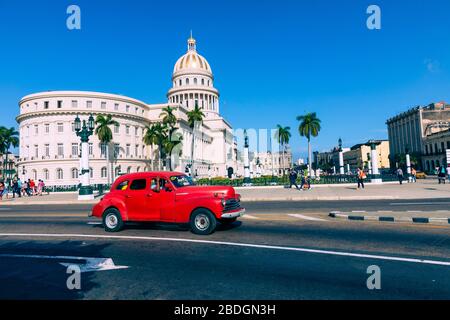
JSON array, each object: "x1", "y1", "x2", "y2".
[{"x1": 386, "y1": 102, "x2": 450, "y2": 170}]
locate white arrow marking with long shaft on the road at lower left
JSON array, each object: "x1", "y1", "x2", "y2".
[{"x1": 0, "y1": 254, "x2": 128, "y2": 272}]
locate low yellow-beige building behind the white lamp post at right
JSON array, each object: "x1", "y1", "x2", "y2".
[{"x1": 344, "y1": 140, "x2": 390, "y2": 172}]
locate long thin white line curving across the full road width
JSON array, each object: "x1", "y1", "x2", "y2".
[{"x1": 0, "y1": 233, "x2": 450, "y2": 267}]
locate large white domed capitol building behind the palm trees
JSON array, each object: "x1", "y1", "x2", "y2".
[{"x1": 16, "y1": 36, "x2": 242, "y2": 186}]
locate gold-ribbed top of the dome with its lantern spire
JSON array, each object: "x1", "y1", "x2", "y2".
[{"x1": 173, "y1": 35, "x2": 212, "y2": 76}]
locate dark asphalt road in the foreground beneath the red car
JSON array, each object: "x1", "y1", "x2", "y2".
[{"x1": 0, "y1": 200, "x2": 450, "y2": 300}]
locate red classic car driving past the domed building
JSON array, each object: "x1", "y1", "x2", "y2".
[{"x1": 90, "y1": 172, "x2": 245, "y2": 235}]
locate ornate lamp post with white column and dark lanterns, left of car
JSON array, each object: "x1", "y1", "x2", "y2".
[{"x1": 75, "y1": 114, "x2": 95, "y2": 200}]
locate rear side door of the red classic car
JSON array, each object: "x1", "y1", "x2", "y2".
[{"x1": 125, "y1": 178, "x2": 160, "y2": 221}]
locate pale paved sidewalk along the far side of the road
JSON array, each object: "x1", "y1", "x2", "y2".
[{"x1": 0, "y1": 179, "x2": 450, "y2": 207}]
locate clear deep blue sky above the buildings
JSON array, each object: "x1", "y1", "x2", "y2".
[{"x1": 0, "y1": 0, "x2": 450, "y2": 160}]
